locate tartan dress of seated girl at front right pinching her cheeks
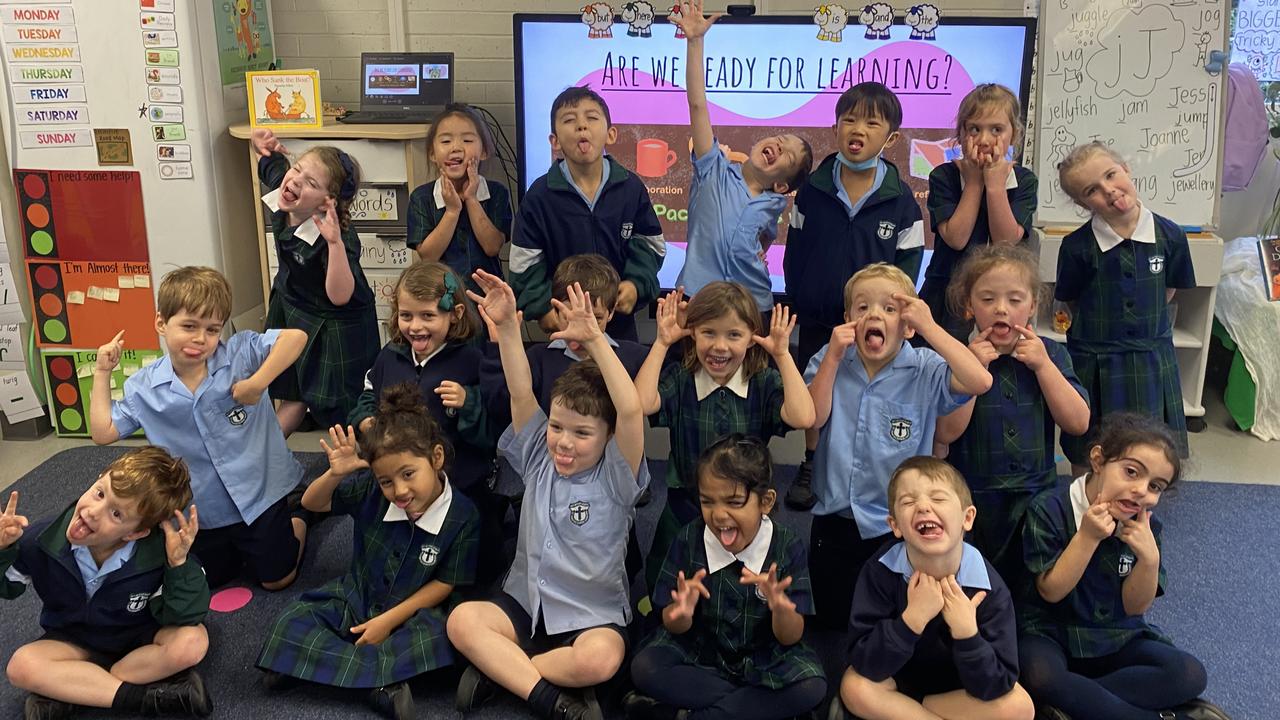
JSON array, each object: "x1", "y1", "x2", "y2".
[{"x1": 1018, "y1": 475, "x2": 1172, "y2": 659}]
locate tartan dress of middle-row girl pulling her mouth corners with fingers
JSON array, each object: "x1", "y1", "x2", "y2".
[{"x1": 947, "y1": 338, "x2": 1089, "y2": 586}]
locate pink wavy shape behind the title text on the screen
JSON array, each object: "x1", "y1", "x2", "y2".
[{"x1": 575, "y1": 40, "x2": 974, "y2": 128}]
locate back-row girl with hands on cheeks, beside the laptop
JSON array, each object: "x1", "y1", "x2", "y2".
[{"x1": 408, "y1": 102, "x2": 511, "y2": 294}]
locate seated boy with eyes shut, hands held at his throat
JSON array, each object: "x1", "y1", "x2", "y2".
[{"x1": 833, "y1": 456, "x2": 1039, "y2": 720}]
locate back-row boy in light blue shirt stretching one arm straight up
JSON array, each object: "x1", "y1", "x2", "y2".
[{"x1": 672, "y1": 0, "x2": 813, "y2": 312}]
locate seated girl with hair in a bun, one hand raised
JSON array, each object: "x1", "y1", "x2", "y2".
[{"x1": 257, "y1": 383, "x2": 480, "y2": 720}]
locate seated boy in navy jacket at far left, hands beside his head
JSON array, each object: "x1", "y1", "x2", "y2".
[{"x1": 0, "y1": 447, "x2": 212, "y2": 720}]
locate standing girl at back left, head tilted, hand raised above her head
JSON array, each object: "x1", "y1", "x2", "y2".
[{"x1": 252, "y1": 128, "x2": 379, "y2": 436}]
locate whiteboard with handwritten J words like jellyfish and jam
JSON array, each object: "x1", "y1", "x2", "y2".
[{"x1": 1036, "y1": 0, "x2": 1230, "y2": 228}]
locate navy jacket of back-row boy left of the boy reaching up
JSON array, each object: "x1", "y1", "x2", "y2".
[{"x1": 509, "y1": 158, "x2": 667, "y2": 340}]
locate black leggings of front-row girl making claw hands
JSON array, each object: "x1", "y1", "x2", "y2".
[{"x1": 631, "y1": 646, "x2": 827, "y2": 720}]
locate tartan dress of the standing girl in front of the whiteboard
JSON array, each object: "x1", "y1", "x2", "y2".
[{"x1": 1053, "y1": 208, "x2": 1196, "y2": 465}]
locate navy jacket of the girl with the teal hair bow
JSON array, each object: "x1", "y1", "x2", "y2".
[{"x1": 349, "y1": 342, "x2": 497, "y2": 495}]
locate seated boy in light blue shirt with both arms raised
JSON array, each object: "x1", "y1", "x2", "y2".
[{"x1": 448, "y1": 270, "x2": 649, "y2": 720}]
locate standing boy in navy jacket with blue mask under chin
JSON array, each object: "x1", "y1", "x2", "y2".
[{"x1": 782, "y1": 82, "x2": 924, "y2": 510}]
